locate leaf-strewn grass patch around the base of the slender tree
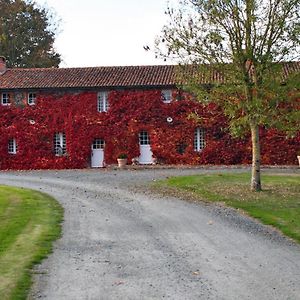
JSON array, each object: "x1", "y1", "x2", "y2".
[{"x1": 156, "y1": 173, "x2": 300, "y2": 242}]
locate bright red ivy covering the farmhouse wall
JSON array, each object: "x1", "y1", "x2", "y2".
[{"x1": 0, "y1": 90, "x2": 300, "y2": 169}]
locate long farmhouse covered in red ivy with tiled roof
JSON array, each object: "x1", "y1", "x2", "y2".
[{"x1": 0, "y1": 57, "x2": 300, "y2": 169}]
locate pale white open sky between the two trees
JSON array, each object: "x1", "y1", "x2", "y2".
[{"x1": 36, "y1": 0, "x2": 171, "y2": 67}]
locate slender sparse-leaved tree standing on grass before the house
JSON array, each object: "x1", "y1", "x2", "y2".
[{"x1": 156, "y1": 0, "x2": 300, "y2": 191}]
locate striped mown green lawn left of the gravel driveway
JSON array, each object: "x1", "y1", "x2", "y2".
[{"x1": 0, "y1": 186, "x2": 63, "y2": 300}]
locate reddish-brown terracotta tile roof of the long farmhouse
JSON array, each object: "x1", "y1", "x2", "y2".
[{"x1": 0, "y1": 62, "x2": 300, "y2": 89}]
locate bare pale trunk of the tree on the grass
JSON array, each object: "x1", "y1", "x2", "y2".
[{"x1": 250, "y1": 122, "x2": 261, "y2": 192}]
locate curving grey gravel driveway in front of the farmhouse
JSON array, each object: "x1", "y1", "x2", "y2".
[{"x1": 0, "y1": 169, "x2": 300, "y2": 300}]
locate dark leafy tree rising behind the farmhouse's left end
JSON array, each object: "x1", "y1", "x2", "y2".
[{"x1": 0, "y1": 0, "x2": 61, "y2": 68}]
